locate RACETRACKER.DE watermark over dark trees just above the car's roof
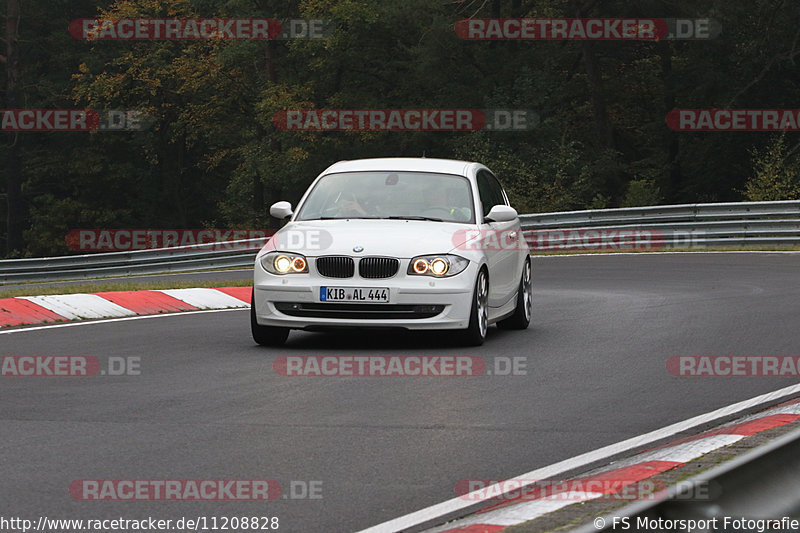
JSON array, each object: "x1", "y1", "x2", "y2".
[{"x1": 272, "y1": 109, "x2": 540, "y2": 132}]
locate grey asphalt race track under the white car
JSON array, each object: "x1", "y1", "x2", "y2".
[{"x1": 0, "y1": 254, "x2": 800, "y2": 533}]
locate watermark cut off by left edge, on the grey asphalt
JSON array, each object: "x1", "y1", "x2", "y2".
[{"x1": 0, "y1": 355, "x2": 142, "y2": 378}]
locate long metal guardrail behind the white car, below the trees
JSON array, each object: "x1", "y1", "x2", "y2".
[{"x1": 0, "y1": 201, "x2": 800, "y2": 284}]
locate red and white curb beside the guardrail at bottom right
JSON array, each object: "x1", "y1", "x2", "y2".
[{"x1": 418, "y1": 400, "x2": 800, "y2": 533}]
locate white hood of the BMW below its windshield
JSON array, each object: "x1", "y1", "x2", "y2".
[{"x1": 261, "y1": 219, "x2": 475, "y2": 259}]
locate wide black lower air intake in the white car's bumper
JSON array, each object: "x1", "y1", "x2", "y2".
[{"x1": 275, "y1": 302, "x2": 444, "y2": 320}]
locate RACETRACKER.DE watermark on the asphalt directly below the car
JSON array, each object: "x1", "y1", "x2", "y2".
[{"x1": 272, "y1": 355, "x2": 528, "y2": 378}]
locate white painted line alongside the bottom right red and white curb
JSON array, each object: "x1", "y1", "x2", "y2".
[{"x1": 359, "y1": 384, "x2": 800, "y2": 533}]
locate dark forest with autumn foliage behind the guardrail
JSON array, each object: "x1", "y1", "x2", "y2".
[{"x1": 0, "y1": 0, "x2": 800, "y2": 255}]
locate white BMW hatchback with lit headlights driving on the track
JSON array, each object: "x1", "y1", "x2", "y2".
[{"x1": 250, "y1": 158, "x2": 532, "y2": 346}]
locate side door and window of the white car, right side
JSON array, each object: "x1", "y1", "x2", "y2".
[{"x1": 476, "y1": 169, "x2": 522, "y2": 308}]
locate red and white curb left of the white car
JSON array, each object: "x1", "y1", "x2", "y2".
[{"x1": 0, "y1": 287, "x2": 251, "y2": 328}]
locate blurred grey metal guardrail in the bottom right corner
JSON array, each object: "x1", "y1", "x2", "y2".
[{"x1": 577, "y1": 424, "x2": 800, "y2": 533}]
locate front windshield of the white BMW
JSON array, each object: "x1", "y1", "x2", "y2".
[{"x1": 296, "y1": 171, "x2": 475, "y2": 223}]
